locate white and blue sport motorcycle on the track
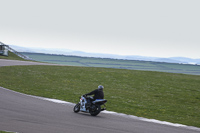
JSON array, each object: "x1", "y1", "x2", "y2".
[{"x1": 73, "y1": 95, "x2": 107, "y2": 116}]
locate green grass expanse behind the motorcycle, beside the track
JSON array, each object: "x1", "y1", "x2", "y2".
[{"x1": 0, "y1": 66, "x2": 200, "y2": 127}]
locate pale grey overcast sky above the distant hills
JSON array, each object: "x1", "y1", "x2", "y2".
[{"x1": 0, "y1": 0, "x2": 200, "y2": 58}]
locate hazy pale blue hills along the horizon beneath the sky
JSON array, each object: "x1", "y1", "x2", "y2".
[{"x1": 10, "y1": 45, "x2": 200, "y2": 64}]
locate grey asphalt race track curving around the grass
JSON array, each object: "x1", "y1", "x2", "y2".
[{"x1": 0, "y1": 59, "x2": 200, "y2": 133}]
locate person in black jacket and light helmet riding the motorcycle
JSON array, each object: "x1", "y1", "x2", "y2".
[{"x1": 85, "y1": 85, "x2": 104, "y2": 106}]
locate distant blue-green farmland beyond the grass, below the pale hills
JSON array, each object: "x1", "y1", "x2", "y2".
[{"x1": 24, "y1": 53, "x2": 200, "y2": 75}]
